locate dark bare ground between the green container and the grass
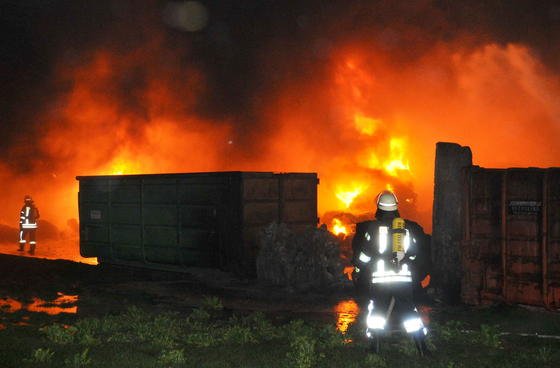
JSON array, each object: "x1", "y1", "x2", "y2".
[{"x1": 0, "y1": 254, "x2": 357, "y2": 323}]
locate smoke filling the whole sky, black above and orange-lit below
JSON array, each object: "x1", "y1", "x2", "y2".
[{"x1": 0, "y1": 0, "x2": 560, "y2": 240}]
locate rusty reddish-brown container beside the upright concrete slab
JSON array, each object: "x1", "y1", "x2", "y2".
[{"x1": 461, "y1": 166, "x2": 560, "y2": 307}]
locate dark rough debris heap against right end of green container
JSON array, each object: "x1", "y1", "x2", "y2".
[{"x1": 257, "y1": 223, "x2": 349, "y2": 291}]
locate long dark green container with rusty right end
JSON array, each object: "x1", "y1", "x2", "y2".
[{"x1": 76, "y1": 172, "x2": 318, "y2": 275}]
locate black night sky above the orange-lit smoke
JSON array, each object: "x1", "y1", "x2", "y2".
[{"x1": 0, "y1": 0, "x2": 560, "y2": 171}]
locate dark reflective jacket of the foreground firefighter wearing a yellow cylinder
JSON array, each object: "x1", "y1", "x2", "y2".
[{"x1": 352, "y1": 216, "x2": 426, "y2": 286}]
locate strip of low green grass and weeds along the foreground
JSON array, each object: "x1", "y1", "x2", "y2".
[{"x1": 0, "y1": 298, "x2": 560, "y2": 368}]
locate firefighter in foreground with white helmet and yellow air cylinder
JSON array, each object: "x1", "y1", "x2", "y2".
[{"x1": 352, "y1": 191, "x2": 427, "y2": 355}]
